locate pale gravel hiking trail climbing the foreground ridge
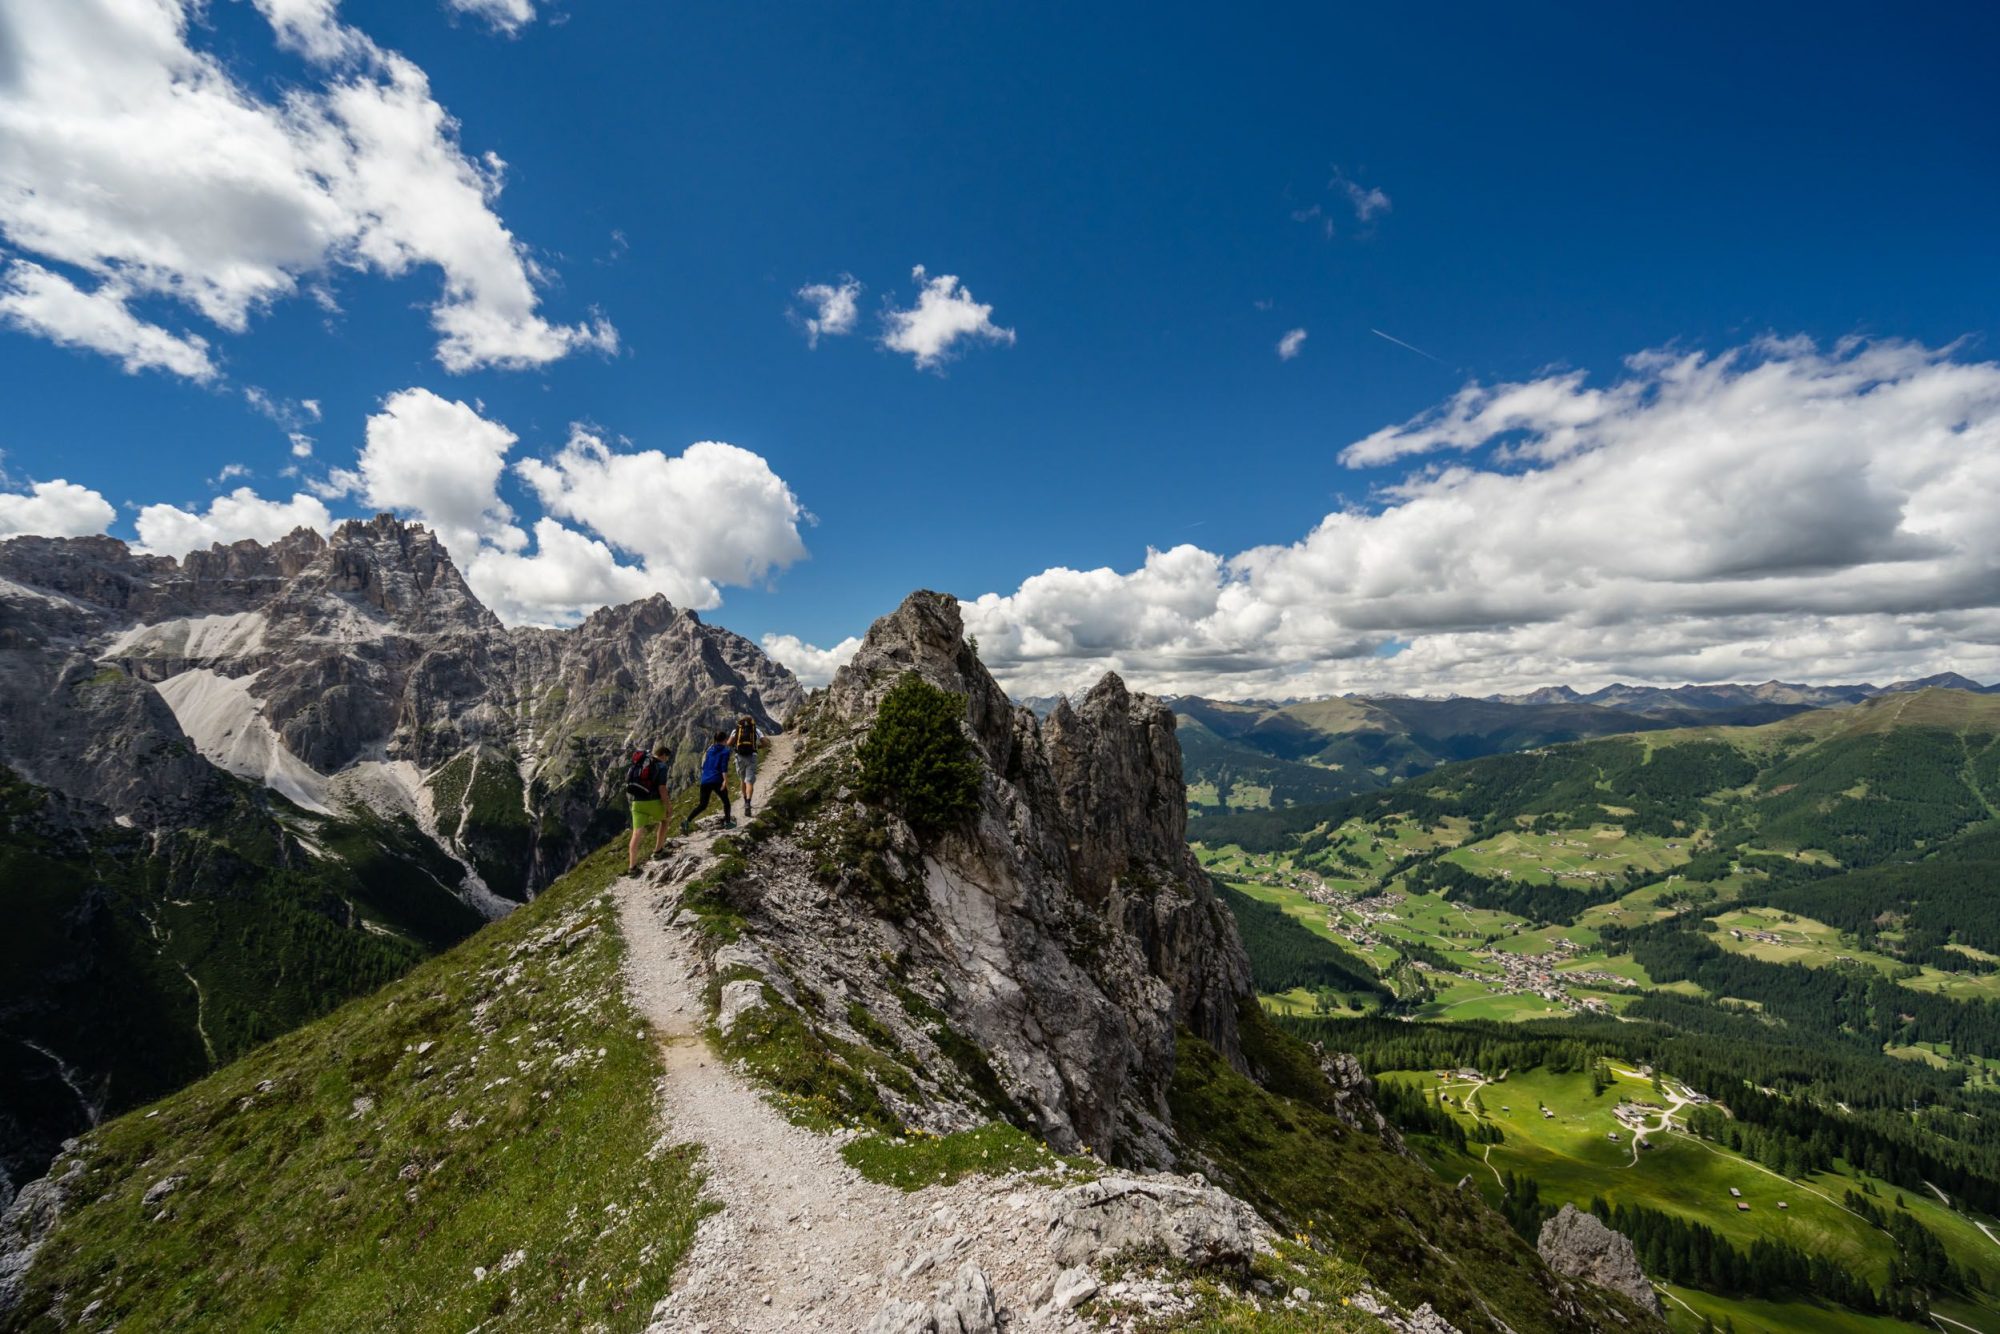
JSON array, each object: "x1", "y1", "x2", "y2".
[{"x1": 612, "y1": 736, "x2": 1082, "y2": 1334}]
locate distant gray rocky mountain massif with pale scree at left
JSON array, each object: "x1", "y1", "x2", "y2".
[{"x1": 0, "y1": 514, "x2": 804, "y2": 912}]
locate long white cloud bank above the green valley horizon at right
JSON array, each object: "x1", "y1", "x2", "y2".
[{"x1": 966, "y1": 340, "x2": 2000, "y2": 696}]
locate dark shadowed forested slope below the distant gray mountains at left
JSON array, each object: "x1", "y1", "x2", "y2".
[{"x1": 0, "y1": 768, "x2": 482, "y2": 1180}]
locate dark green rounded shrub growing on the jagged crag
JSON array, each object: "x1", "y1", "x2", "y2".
[{"x1": 856, "y1": 672, "x2": 980, "y2": 834}]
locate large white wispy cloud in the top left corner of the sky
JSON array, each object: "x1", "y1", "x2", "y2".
[{"x1": 0, "y1": 0, "x2": 618, "y2": 380}]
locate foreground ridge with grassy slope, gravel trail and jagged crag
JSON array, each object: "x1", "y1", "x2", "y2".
[{"x1": 0, "y1": 594, "x2": 1658, "y2": 1334}]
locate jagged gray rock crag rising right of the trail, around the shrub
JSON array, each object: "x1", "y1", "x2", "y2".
[{"x1": 712, "y1": 592, "x2": 1250, "y2": 1166}]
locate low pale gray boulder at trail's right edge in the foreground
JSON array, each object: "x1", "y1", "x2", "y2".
[{"x1": 1048, "y1": 1176, "x2": 1266, "y2": 1270}]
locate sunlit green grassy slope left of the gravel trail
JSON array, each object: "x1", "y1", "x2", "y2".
[{"x1": 4, "y1": 840, "x2": 698, "y2": 1334}]
